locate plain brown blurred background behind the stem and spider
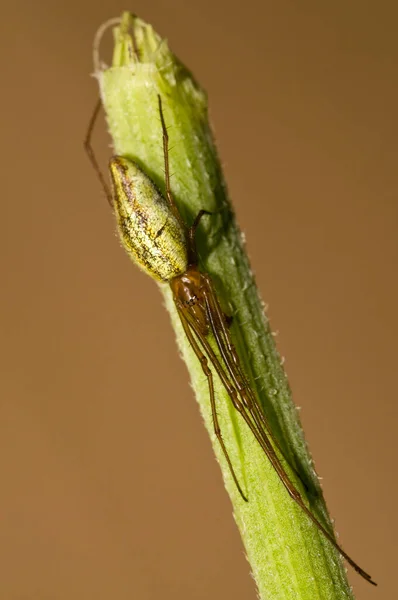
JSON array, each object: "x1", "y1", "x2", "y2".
[{"x1": 0, "y1": 0, "x2": 398, "y2": 600}]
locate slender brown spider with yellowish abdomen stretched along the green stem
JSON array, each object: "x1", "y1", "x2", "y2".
[{"x1": 84, "y1": 95, "x2": 377, "y2": 585}]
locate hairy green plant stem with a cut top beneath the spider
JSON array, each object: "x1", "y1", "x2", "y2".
[{"x1": 96, "y1": 13, "x2": 353, "y2": 600}]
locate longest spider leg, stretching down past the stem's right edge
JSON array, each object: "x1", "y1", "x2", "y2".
[{"x1": 183, "y1": 302, "x2": 377, "y2": 585}]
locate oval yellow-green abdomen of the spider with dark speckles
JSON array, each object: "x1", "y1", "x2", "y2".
[{"x1": 109, "y1": 156, "x2": 188, "y2": 281}]
